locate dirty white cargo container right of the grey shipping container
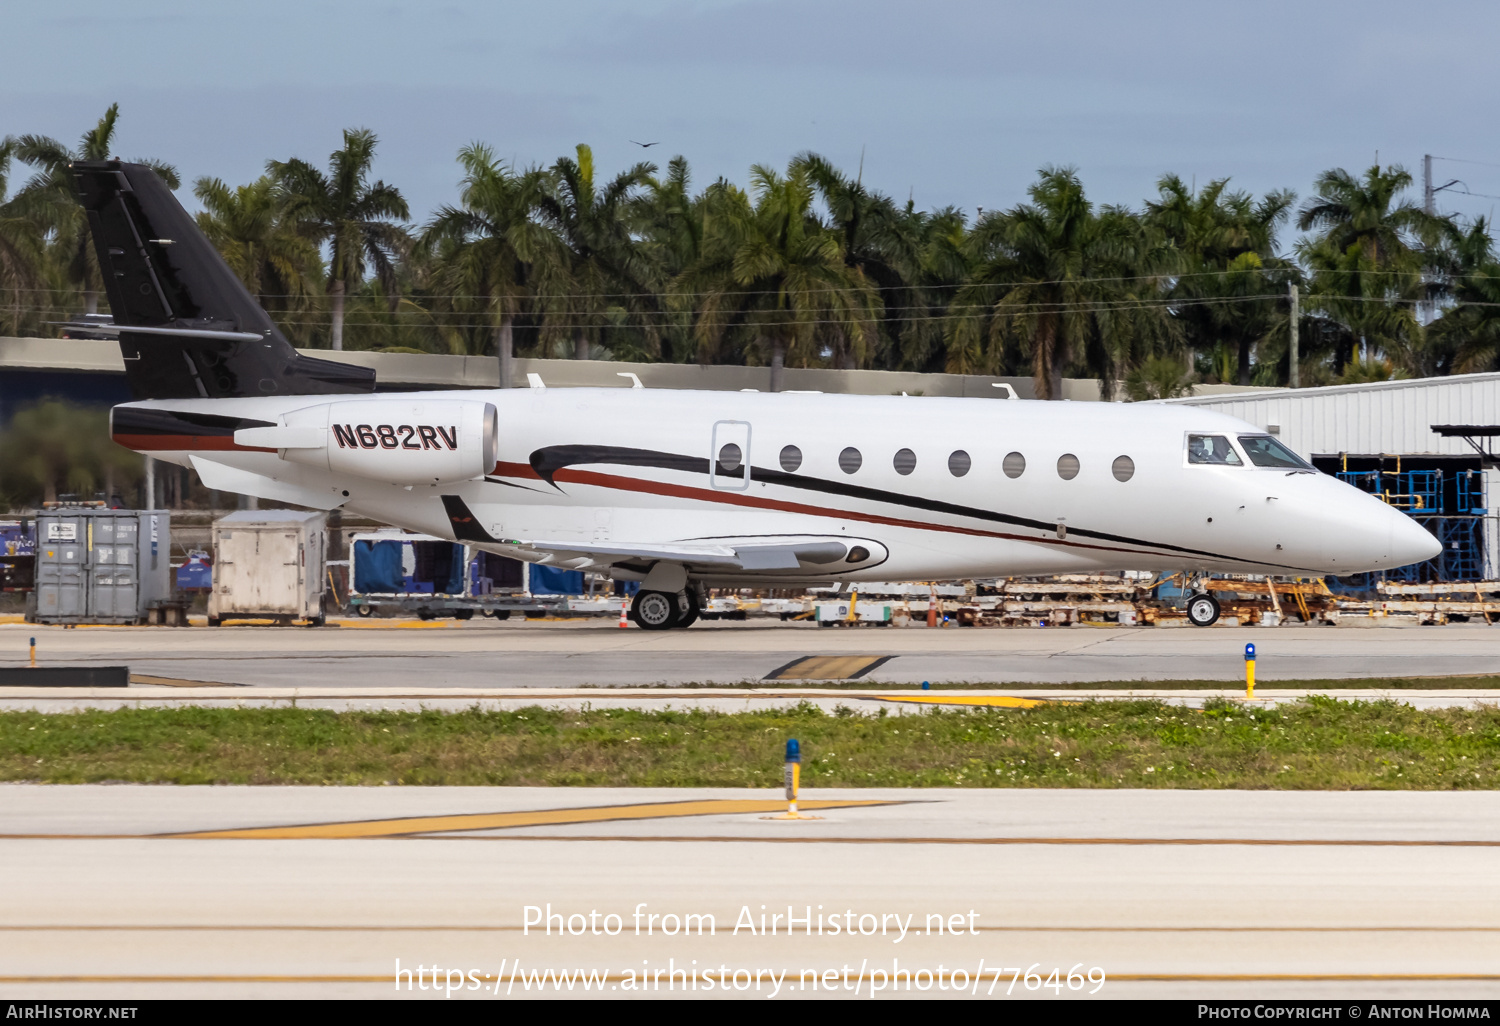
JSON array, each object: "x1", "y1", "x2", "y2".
[{"x1": 209, "y1": 510, "x2": 329, "y2": 627}]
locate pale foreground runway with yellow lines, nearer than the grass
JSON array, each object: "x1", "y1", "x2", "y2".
[{"x1": 0, "y1": 785, "x2": 1500, "y2": 1001}]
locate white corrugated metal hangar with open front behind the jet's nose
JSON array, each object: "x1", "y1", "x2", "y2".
[{"x1": 1166, "y1": 374, "x2": 1500, "y2": 581}]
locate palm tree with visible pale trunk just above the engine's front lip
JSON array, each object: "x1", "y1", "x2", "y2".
[{"x1": 422, "y1": 143, "x2": 567, "y2": 389}]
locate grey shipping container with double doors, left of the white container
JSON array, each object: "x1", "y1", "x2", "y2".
[{"x1": 36, "y1": 509, "x2": 171, "y2": 624}]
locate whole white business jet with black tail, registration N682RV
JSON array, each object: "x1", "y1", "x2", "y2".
[{"x1": 72, "y1": 161, "x2": 1440, "y2": 630}]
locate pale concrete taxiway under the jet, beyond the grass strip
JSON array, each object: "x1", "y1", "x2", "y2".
[{"x1": 0, "y1": 620, "x2": 1500, "y2": 689}]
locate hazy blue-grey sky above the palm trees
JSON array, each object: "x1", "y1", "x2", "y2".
[{"x1": 0, "y1": 0, "x2": 1500, "y2": 232}]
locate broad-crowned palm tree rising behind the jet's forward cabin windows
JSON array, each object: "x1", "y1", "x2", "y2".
[{"x1": 948, "y1": 168, "x2": 1170, "y2": 399}]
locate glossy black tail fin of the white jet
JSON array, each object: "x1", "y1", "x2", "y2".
[{"x1": 71, "y1": 161, "x2": 375, "y2": 399}]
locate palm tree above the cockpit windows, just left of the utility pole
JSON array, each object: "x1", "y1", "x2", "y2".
[{"x1": 1145, "y1": 174, "x2": 1296, "y2": 384}]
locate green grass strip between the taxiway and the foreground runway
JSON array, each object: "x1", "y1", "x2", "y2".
[{"x1": 0, "y1": 698, "x2": 1500, "y2": 791}]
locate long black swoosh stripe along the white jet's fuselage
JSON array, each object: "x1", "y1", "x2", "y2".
[{"x1": 531, "y1": 446, "x2": 1302, "y2": 569}]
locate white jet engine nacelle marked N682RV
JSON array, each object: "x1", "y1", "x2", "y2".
[{"x1": 234, "y1": 399, "x2": 500, "y2": 485}]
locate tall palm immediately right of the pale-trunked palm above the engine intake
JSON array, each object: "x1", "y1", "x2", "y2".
[{"x1": 539, "y1": 144, "x2": 657, "y2": 360}]
